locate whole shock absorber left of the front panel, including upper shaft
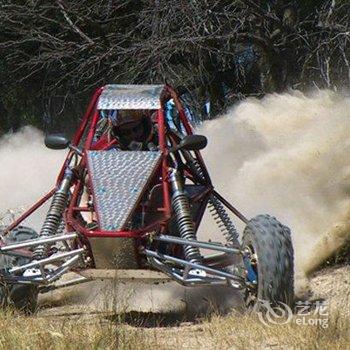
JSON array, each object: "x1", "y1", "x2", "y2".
[{"x1": 33, "y1": 168, "x2": 73, "y2": 260}]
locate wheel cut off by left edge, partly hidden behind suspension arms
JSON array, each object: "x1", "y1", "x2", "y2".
[{"x1": 0, "y1": 226, "x2": 38, "y2": 313}]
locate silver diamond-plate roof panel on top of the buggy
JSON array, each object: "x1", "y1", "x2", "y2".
[{"x1": 97, "y1": 85, "x2": 164, "y2": 109}]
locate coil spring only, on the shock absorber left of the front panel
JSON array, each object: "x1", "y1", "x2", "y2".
[{"x1": 33, "y1": 192, "x2": 68, "y2": 260}]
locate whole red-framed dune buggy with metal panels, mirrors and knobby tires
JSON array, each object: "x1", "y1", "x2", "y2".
[{"x1": 0, "y1": 85, "x2": 293, "y2": 312}]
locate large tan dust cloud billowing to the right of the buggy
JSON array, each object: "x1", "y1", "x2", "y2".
[{"x1": 198, "y1": 91, "x2": 350, "y2": 272}]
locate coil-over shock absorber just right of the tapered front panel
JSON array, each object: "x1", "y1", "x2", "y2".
[{"x1": 170, "y1": 169, "x2": 201, "y2": 263}]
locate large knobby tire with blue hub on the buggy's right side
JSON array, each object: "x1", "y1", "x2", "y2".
[{"x1": 242, "y1": 215, "x2": 294, "y2": 308}]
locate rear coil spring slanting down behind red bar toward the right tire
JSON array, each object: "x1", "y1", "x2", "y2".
[{"x1": 191, "y1": 158, "x2": 239, "y2": 245}]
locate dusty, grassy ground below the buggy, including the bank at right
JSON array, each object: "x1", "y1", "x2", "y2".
[{"x1": 0, "y1": 266, "x2": 350, "y2": 350}]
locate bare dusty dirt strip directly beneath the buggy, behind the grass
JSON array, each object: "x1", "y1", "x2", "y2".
[{"x1": 39, "y1": 280, "x2": 243, "y2": 319}]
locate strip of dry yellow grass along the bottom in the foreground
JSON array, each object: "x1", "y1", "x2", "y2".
[{"x1": 0, "y1": 311, "x2": 350, "y2": 350}]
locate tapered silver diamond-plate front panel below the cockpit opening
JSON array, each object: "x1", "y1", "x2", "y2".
[{"x1": 87, "y1": 149, "x2": 161, "y2": 231}]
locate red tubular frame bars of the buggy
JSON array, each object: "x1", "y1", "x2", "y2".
[{"x1": 5, "y1": 86, "x2": 246, "y2": 245}]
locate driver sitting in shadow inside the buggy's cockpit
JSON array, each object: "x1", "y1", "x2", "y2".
[{"x1": 112, "y1": 110, "x2": 157, "y2": 151}]
